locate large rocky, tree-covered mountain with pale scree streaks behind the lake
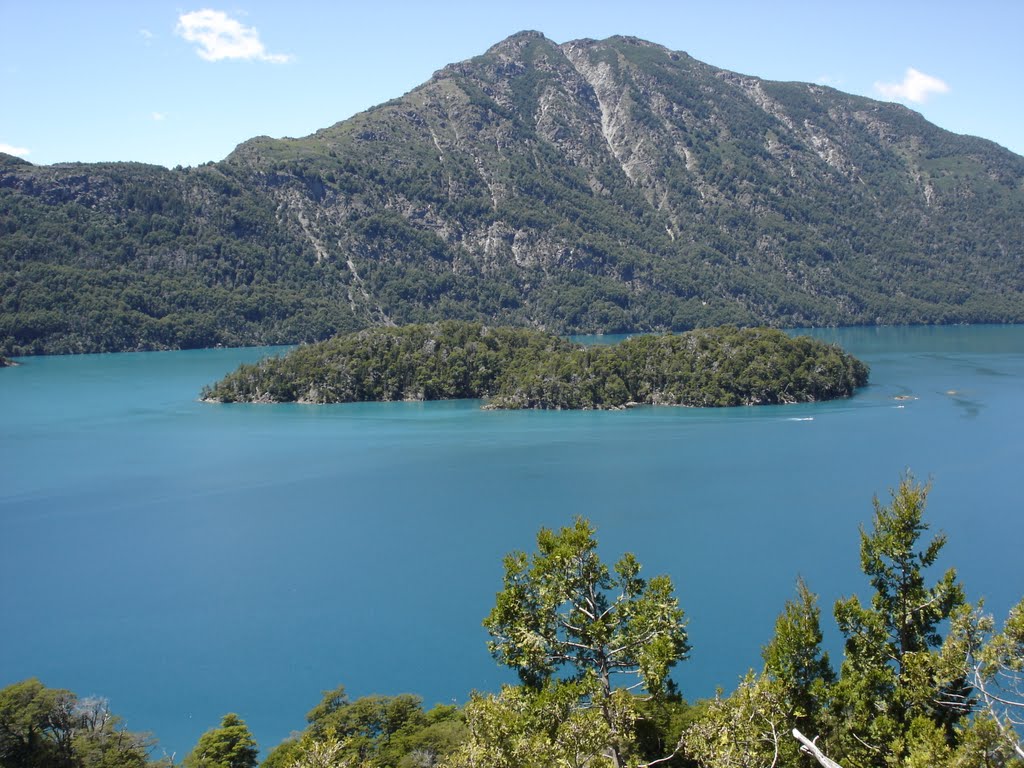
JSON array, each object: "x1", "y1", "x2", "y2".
[{"x1": 0, "y1": 32, "x2": 1024, "y2": 354}]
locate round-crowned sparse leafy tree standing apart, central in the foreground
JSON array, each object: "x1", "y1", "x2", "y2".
[{"x1": 483, "y1": 517, "x2": 690, "y2": 768}]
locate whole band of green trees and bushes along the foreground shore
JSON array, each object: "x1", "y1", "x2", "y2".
[{"x1": 0, "y1": 474, "x2": 1024, "y2": 768}]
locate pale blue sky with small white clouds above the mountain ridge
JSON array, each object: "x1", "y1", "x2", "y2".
[{"x1": 0, "y1": 0, "x2": 1024, "y2": 166}]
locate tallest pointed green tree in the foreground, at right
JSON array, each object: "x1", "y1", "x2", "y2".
[{"x1": 835, "y1": 473, "x2": 969, "y2": 765}]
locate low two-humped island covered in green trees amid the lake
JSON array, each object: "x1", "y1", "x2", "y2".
[{"x1": 201, "y1": 321, "x2": 868, "y2": 410}]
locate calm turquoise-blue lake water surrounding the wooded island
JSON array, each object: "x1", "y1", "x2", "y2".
[{"x1": 0, "y1": 326, "x2": 1024, "y2": 759}]
